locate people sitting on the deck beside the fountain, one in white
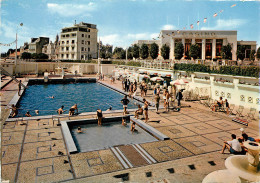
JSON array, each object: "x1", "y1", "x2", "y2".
[{"x1": 220, "y1": 128, "x2": 260, "y2": 155}]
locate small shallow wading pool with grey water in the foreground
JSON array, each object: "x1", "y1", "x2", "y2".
[{"x1": 61, "y1": 116, "x2": 158, "y2": 153}]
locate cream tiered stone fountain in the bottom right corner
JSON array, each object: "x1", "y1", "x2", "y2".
[{"x1": 203, "y1": 141, "x2": 260, "y2": 183}]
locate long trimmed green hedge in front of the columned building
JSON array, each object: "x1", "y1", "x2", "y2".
[{"x1": 174, "y1": 64, "x2": 260, "y2": 78}]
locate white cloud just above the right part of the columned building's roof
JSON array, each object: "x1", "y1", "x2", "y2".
[{"x1": 201, "y1": 19, "x2": 247, "y2": 30}]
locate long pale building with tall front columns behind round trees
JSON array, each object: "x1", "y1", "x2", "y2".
[{"x1": 135, "y1": 30, "x2": 256, "y2": 60}]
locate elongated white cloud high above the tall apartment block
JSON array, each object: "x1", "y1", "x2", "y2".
[{"x1": 47, "y1": 2, "x2": 96, "y2": 17}]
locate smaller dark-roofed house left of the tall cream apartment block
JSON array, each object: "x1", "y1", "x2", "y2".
[{"x1": 28, "y1": 37, "x2": 50, "y2": 54}]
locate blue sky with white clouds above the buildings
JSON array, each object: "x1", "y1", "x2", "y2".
[{"x1": 0, "y1": 0, "x2": 260, "y2": 52}]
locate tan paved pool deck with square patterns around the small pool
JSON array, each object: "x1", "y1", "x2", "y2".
[{"x1": 1, "y1": 75, "x2": 259, "y2": 182}]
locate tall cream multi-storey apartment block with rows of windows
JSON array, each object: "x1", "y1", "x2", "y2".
[{"x1": 59, "y1": 22, "x2": 98, "y2": 60}]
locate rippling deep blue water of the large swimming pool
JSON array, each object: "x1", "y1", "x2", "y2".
[{"x1": 18, "y1": 83, "x2": 141, "y2": 116}]
